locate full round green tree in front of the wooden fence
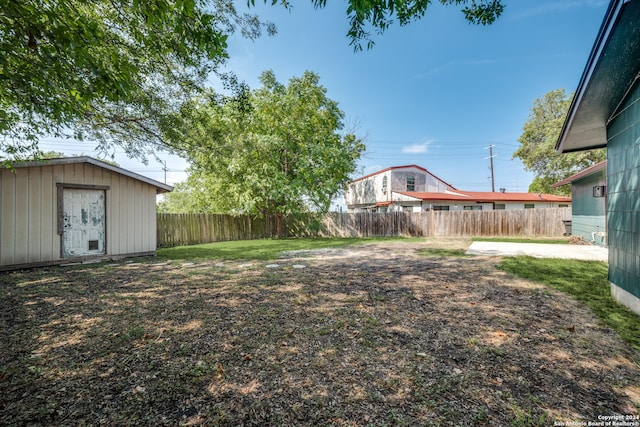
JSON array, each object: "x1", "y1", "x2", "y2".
[{"x1": 162, "y1": 71, "x2": 365, "y2": 232}]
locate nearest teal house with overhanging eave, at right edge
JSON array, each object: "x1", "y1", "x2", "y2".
[{"x1": 556, "y1": 0, "x2": 640, "y2": 314}]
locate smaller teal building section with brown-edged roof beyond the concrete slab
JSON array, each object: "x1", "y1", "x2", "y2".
[{"x1": 552, "y1": 160, "x2": 607, "y2": 246}]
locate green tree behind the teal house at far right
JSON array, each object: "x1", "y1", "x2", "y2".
[{"x1": 513, "y1": 89, "x2": 607, "y2": 195}]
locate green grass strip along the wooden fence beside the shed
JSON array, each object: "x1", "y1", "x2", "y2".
[{"x1": 158, "y1": 237, "x2": 423, "y2": 260}]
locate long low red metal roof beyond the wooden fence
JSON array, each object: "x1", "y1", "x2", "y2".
[{"x1": 394, "y1": 191, "x2": 571, "y2": 203}]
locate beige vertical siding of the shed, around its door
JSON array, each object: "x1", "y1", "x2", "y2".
[{"x1": 0, "y1": 163, "x2": 156, "y2": 266}]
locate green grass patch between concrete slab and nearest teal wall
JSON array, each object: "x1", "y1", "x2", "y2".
[{"x1": 500, "y1": 257, "x2": 640, "y2": 351}]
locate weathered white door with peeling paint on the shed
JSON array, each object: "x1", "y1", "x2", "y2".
[{"x1": 62, "y1": 188, "x2": 105, "y2": 257}]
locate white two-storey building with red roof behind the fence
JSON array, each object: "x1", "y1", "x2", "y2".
[{"x1": 345, "y1": 165, "x2": 571, "y2": 212}]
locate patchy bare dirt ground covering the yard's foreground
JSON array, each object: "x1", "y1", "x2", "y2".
[{"x1": 0, "y1": 240, "x2": 640, "y2": 426}]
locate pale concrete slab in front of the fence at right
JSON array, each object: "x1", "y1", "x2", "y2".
[{"x1": 466, "y1": 242, "x2": 609, "y2": 262}]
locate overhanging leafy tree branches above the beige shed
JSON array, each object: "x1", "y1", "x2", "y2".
[{"x1": 0, "y1": 0, "x2": 272, "y2": 157}]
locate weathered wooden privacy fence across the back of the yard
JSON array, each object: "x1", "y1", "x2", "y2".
[{"x1": 158, "y1": 208, "x2": 571, "y2": 247}]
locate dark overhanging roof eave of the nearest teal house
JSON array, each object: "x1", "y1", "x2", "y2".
[{"x1": 556, "y1": 0, "x2": 640, "y2": 153}]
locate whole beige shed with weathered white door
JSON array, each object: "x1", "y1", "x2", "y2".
[{"x1": 0, "y1": 157, "x2": 172, "y2": 270}]
